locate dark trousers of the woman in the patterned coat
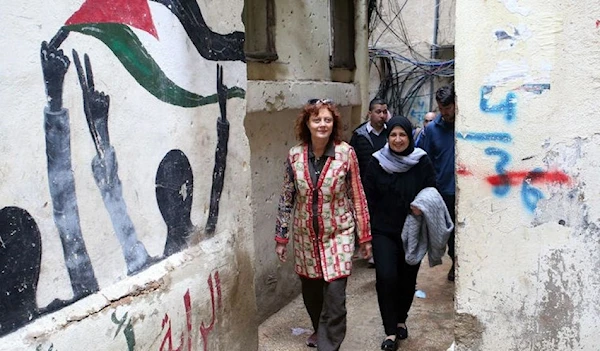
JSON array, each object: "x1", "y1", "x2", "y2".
[{"x1": 300, "y1": 277, "x2": 348, "y2": 351}]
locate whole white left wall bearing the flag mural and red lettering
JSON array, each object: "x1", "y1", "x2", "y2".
[{"x1": 0, "y1": 0, "x2": 257, "y2": 350}]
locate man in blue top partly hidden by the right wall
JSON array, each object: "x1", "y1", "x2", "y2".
[{"x1": 417, "y1": 85, "x2": 456, "y2": 281}]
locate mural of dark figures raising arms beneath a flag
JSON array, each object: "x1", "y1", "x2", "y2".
[{"x1": 0, "y1": 0, "x2": 245, "y2": 338}]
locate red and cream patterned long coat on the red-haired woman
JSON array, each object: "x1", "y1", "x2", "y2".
[{"x1": 275, "y1": 142, "x2": 371, "y2": 282}]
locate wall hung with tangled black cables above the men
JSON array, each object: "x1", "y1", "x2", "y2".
[{"x1": 368, "y1": 0, "x2": 454, "y2": 122}]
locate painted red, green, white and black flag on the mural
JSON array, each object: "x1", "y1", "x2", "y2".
[{"x1": 62, "y1": 0, "x2": 245, "y2": 107}]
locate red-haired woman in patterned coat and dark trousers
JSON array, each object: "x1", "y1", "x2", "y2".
[{"x1": 275, "y1": 100, "x2": 371, "y2": 351}]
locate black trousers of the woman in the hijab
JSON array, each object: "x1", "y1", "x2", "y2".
[{"x1": 371, "y1": 231, "x2": 421, "y2": 335}]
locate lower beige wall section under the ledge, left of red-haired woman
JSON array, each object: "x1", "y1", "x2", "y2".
[{"x1": 244, "y1": 110, "x2": 300, "y2": 323}]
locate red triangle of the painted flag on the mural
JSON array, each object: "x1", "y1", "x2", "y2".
[{"x1": 65, "y1": 0, "x2": 158, "y2": 39}]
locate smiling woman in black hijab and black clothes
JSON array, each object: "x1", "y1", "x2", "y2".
[{"x1": 363, "y1": 116, "x2": 435, "y2": 351}]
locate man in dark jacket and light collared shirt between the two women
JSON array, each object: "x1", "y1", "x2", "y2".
[{"x1": 350, "y1": 98, "x2": 388, "y2": 179}]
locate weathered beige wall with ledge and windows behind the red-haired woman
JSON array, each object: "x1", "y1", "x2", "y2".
[{"x1": 245, "y1": 0, "x2": 368, "y2": 321}]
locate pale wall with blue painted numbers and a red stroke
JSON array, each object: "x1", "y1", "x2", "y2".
[{"x1": 456, "y1": 0, "x2": 600, "y2": 351}]
